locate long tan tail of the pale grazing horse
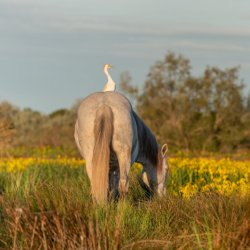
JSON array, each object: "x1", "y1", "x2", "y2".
[{"x1": 91, "y1": 105, "x2": 113, "y2": 203}]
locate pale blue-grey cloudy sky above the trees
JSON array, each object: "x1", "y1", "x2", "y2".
[{"x1": 0, "y1": 0, "x2": 250, "y2": 113}]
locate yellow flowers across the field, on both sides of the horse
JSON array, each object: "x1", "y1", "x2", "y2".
[{"x1": 0, "y1": 155, "x2": 250, "y2": 198}]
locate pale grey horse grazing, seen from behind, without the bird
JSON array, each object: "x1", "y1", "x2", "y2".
[{"x1": 74, "y1": 91, "x2": 168, "y2": 203}]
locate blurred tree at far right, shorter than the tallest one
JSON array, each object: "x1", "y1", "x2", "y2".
[{"x1": 203, "y1": 67, "x2": 244, "y2": 150}]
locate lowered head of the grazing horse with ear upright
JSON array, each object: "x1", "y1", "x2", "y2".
[{"x1": 157, "y1": 144, "x2": 169, "y2": 196}]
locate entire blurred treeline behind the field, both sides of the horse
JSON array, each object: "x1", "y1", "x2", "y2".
[{"x1": 0, "y1": 53, "x2": 250, "y2": 152}]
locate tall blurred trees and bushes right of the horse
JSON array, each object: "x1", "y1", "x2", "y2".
[{"x1": 121, "y1": 53, "x2": 250, "y2": 152}]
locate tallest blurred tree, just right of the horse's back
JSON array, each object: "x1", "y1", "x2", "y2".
[{"x1": 137, "y1": 53, "x2": 191, "y2": 148}]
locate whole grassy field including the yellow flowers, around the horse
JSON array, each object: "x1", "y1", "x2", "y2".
[{"x1": 0, "y1": 154, "x2": 250, "y2": 249}]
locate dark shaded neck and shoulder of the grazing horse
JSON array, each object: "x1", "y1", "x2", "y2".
[{"x1": 132, "y1": 111, "x2": 158, "y2": 166}]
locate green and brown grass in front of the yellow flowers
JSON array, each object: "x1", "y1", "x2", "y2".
[{"x1": 0, "y1": 166, "x2": 250, "y2": 249}]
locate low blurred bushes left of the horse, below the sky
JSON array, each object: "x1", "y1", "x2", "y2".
[{"x1": 0, "y1": 102, "x2": 78, "y2": 153}]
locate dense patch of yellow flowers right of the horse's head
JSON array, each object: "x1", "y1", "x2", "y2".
[{"x1": 169, "y1": 158, "x2": 250, "y2": 198}]
